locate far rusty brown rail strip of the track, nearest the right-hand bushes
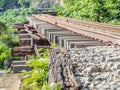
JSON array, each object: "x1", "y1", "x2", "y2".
[{"x1": 38, "y1": 14, "x2": 120, "y2": 32}]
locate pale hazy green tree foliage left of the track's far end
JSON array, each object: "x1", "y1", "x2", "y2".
[{"x1": 0, "y1": 8, "x2": 36, "y2": 27}]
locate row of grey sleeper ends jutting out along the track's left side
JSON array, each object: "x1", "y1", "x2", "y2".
[{"x1": 27, "y1": 16, "x2": 106, "y2": 49}]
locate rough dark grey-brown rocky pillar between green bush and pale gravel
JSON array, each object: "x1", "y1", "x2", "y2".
[{"x1": 49, "y1": 48, "x2": 78, "y2": 90}]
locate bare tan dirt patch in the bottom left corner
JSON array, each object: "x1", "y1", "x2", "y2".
[{"x1": 0, "y1": 74, "x2": 21, "y2": 90}]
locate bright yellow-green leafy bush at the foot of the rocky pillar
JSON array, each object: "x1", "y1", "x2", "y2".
[{"x1": 21, "y1": 48, "x2": 61, "y2": 90}]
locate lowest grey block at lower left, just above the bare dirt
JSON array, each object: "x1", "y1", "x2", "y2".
[{"x1": 12, "y1": 65, "x2": 31, "y2": 73}]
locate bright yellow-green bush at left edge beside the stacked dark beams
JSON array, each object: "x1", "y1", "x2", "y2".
[{"x1": 0, "y1": 42, "x2": 11, "y2": 68}]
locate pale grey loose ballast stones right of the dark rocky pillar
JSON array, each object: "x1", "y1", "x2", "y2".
[{"x1": 67, "y1": 46, "x2": 120, "y2": 90}]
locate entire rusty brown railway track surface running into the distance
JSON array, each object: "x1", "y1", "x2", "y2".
[{"x1": 33, "y1": 14, "x2": 120, "y2": 45}]
